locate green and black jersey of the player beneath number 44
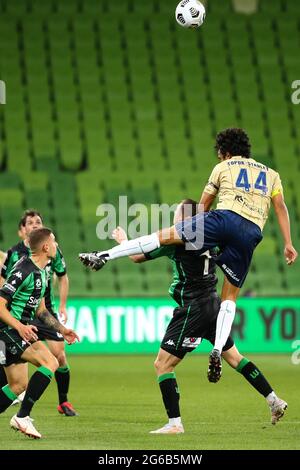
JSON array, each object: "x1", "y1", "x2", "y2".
[{"x1": 145, "y1": 245, "x2": 218, "y2": 306}]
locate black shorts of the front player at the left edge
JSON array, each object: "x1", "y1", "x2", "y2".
[{"x1": 0, "y1": 327, "x2": 30, "y2": 367}]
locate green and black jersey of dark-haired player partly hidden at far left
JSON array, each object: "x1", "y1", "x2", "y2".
[{"x1": 1, "y1": 241, "x2": 67, "y2": 314}]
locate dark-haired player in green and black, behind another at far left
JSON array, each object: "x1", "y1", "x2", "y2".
[{"x1": 0, "y1": 210, "x2": 77, "y2": 416}]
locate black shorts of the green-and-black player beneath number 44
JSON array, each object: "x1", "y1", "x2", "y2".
[{"x1": 160, "y1": 293, "x2": 234, "y2": 359}]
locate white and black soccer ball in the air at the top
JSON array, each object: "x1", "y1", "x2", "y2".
[{"x1": 175, "y1": 0, "x2": 205, "y2": 28}]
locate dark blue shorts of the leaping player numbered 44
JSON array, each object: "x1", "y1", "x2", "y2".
[{"x1": 175, "y1": 210, "x2": 263, "y2": 287}]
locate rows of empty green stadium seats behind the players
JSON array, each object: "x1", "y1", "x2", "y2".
[{"x1": 0, "y1": 0, "x2": 300, "y2": 296}]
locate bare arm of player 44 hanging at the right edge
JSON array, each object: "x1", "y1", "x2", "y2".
[{"x1": 272, "y1": 193, "x2": 298, "y2": 264}]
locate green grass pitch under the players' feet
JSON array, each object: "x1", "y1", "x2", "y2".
[{"x1": 0, "y1": 355, "x2": 300, "y2": 450}]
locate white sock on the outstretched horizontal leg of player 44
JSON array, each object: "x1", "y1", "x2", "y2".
[{"x1": 107, "y1": 233, "x2": 160, "y2": 259}]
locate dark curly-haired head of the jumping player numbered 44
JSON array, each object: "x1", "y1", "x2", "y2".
[{"x1": 215, "y1": 128, "x2": 251, "y2": 161}]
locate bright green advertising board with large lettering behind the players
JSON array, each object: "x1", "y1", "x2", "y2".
[{"x1": 62, "y1": 298, "x2": 300, "y2": 354}]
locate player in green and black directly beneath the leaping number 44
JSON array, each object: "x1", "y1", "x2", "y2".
[{"x1": 113, "y1": 199, "x2": 287, "y2": 434}]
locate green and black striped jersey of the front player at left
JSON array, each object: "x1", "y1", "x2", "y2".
[{"x1": 0, "y1": 256, "x2": 47, "y2": 328}]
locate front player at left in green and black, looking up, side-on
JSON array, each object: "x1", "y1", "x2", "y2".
[{"x1": 0, "y1": 228, "x2": 78, "y2": 438}]
